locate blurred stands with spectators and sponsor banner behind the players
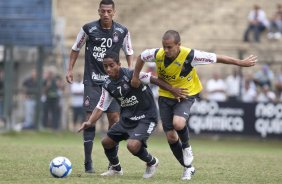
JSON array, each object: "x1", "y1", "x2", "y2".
[{"x1": 0, "y1": 0, "x2": 282, "y2": 138}]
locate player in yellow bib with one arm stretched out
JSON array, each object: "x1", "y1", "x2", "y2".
[{"x1": 131, "y1": 30, "x2": 257, "y2": 180}]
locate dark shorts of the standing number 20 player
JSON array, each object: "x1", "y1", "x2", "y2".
[{"x1": 83, "y1": 85, "x2": 120, "y2": 112}]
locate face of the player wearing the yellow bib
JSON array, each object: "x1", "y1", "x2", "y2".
[{"x1": 163, "y1": 38, "x2": 180, "y2": 59}]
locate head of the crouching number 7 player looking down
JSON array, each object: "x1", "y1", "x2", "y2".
[{"x1": 103, "y1": 58, "x2": 120, "y2": 79}]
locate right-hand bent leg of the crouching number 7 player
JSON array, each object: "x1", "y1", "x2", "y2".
[{"x1": 127, "y1": 119, "x2": 159, "y2": 179}]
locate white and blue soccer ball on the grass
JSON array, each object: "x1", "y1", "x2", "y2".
[{"x1": 50, "y1": 156, "x2": 72, "y2": 178}]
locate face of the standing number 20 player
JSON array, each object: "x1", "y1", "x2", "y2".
[{"x1": 98, "y1": 4, "x2": 115, "y2": 24}]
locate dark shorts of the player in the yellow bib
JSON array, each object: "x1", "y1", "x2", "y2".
[{"x1": 158, "y1": 95, "x2": 199, "y2": 132}]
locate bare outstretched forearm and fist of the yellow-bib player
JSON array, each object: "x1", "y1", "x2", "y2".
[{"x1": 217, "y1": 55, "x2": 258, "y2": 67}]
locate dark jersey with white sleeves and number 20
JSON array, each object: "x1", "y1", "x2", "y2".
[{"x1": 72, "y1": 20, "x2": 133, "y2": 85}]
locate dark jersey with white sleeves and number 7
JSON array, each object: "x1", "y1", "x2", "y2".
[{"x1": 97, "y1": 68, "x2": 158, "y2": 128}]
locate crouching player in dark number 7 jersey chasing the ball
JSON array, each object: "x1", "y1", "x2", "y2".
[{"x1": 78, "y1": 52, "x2": 184, "y2": 178}]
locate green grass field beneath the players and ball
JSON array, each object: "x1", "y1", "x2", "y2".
[{"x1": 0, "y1": 132, "x2": 282, "y2": 184}]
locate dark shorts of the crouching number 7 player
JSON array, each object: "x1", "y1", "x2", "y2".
[{"x1": 107, "y1": 119, "x2": 157, "y2": 146}]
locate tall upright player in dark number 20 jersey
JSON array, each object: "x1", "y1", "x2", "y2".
[{"x1": 66, "y1": 0, "x2": 133, "y2": 173}]
